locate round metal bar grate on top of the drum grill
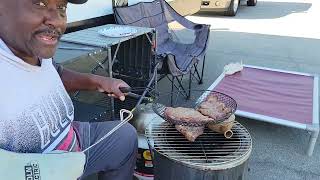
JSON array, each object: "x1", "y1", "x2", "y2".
[{"x1": 146, "y1": 117, "x2": 252, "y2": 168}]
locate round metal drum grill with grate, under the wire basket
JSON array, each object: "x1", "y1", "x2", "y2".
[{"x1": 146, "y1": 117, "x2": 252, "y2": 180}]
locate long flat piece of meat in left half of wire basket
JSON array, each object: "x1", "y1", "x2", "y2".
[{"x1": 164, "y1": 107, "x2": 213, "y2": 123}]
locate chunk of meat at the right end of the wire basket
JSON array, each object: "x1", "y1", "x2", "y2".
[{"x1": 198, "y1": 95, "x2": 231, "y2": 119}]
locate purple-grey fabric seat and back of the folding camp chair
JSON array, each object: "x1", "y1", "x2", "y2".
[{"x1": 114, "y1": 0, "x2": 209, "y2": 76}]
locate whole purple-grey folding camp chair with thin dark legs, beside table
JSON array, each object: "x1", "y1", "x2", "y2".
[{"x1": 114, "y1": 0, "x2": 210, "y2": 97}]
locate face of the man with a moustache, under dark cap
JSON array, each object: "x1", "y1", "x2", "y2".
[{"x1": 0, "y1": 0, "x2": 67, "y2": 58}]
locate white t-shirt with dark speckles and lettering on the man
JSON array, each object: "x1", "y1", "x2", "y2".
[{"x1": 0, "y1": 39, "x2": 77, "y2": 153}]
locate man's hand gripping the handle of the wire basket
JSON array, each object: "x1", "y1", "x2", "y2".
[{"x1": 92, "y1": 75, "x2": 129, "y2": 101}]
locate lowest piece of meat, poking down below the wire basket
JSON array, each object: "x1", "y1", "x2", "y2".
[{"x1": 175, "y1": 125, "x2": 204, "y2": 142}]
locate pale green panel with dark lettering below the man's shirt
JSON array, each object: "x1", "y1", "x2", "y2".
[{"x1": 0, "y1": 149, "x2": 85, "y2": 180}]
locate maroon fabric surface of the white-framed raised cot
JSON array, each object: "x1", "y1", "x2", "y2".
[{"x1": 214, "y1": 67, "x2": 314, "y2": 124}]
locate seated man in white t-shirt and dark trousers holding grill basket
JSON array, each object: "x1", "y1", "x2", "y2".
[{"x1": 0, "y1": 0, "x2": 137, "y2": 180}]
